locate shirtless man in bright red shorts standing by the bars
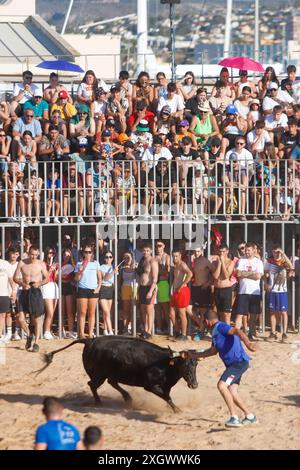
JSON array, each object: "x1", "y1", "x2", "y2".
[{"x1": 170, "y1": 250, "x2": 193, "y2": 341}]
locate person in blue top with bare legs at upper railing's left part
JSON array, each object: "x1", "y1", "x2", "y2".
[{"x1": 45, "y1": 165, "x2": 61, "y2": 224}]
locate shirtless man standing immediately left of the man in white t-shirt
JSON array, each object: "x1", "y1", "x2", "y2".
[{"x1": 213, "y1": 243, "x2": 235, "y2": 325}]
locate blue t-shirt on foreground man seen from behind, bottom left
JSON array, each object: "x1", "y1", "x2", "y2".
[{"x1": 35, "y1": 420, "x2": 80, "y2": 450}]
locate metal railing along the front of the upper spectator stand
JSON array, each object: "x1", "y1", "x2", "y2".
[{"x1": 0, "y1": 159, "x2": 300, "y2": 224}]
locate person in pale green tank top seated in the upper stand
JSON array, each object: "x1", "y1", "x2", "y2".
[{"x1": 190, "y1": 105, "x2": 221, "y2": 147}]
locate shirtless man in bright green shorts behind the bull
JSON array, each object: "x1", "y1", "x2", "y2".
[{"x1": 155, "y1": 240, "x2": 171, "y2": 333}]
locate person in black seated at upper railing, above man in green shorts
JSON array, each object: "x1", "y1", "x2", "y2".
[{"x1": 148, "y1": 157, "x2": 177, "y2": 213}]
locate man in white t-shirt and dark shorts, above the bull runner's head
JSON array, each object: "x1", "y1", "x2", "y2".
[{"x1": 235, "y1": 242, "x2": 264, "y2": 339}]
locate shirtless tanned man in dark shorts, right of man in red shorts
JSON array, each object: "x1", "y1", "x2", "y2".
[{"x1": 192, "y1": 247, "x2": 214, "y2": 340}]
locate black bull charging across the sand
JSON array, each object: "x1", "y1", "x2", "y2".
[{"x1": 41, "y1": 336, "x2": 198, "y2": 411}]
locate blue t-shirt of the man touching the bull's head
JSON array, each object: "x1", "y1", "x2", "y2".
[{"x1": 212, "y1": 322, "x2": 251, "y2": 367}]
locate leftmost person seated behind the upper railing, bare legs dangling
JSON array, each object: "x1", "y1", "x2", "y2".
[{"x1": 2, "y1": 162, "x2": 25, "y2": 222}]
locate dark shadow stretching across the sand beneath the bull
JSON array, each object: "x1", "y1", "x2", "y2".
[{"x1": 0, "y1": 392, "x2": 192, "y2": 426}]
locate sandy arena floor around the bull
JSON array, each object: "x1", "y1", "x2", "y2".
[{"x1": 0, "y1": 335, "x2": 300, "y2": 450}]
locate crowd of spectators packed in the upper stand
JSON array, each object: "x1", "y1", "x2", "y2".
[{"x1": 0, "y1": 65, "x2": 300, "y2": 224}]
